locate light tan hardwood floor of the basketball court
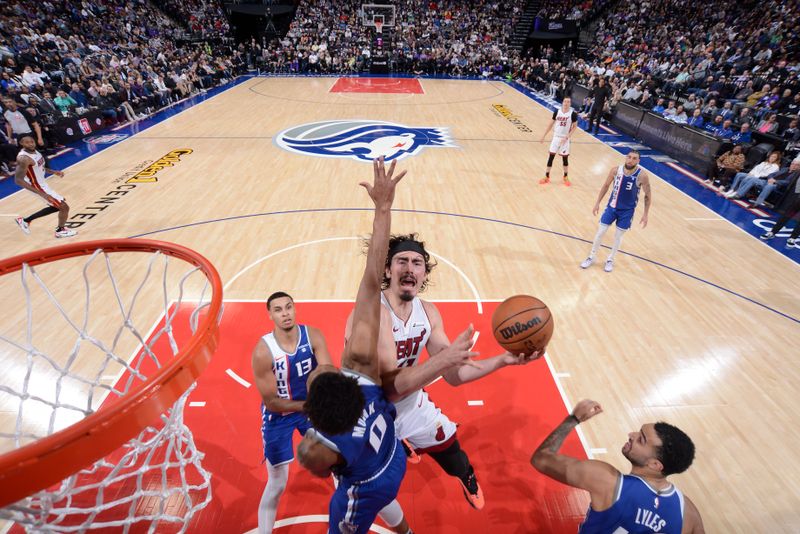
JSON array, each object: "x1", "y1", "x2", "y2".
[{"x1": 0, "y1": 78, "x2": 800, "y2": 532}]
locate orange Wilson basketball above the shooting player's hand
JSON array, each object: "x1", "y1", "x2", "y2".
[{"x1": 492, "y1": 295, "x2": 553, "y2": 355}]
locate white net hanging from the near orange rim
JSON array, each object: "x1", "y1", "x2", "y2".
[{"x1": 0, "y1": 250, "x2": 216, "y2": 532}]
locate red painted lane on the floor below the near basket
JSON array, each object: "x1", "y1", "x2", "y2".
[{"x1": 10, "y1": 302, "x2": 588, "y2": 534}]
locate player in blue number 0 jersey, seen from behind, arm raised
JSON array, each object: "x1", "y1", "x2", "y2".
[{"x1": 297, "y1": 158, "x2": 470, "y2": 534}]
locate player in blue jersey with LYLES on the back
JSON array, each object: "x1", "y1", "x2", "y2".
[{"x1": 531, "y1": 400, "x2": 705, "y2": 534}]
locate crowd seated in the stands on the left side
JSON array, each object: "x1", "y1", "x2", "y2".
[{"x1": 0, "y1": 0, "x2": 246, "y2": 172}]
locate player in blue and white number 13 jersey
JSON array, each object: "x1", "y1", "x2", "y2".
[{"x1": 252, "y1": 292, "x2": 331, "y2": 534}]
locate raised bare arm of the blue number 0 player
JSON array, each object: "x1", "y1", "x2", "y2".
[{"x1": 342, "y1": 156, "x2": 406, "y2": 383}]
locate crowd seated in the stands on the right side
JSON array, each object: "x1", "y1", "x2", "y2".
[{"x1": 518, "y1": 0, "x2": 800, "y2": 206}]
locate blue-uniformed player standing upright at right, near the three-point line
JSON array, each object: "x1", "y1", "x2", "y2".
[{"x1": 581, "y1": 150, "x2": 652, "y2": 273}]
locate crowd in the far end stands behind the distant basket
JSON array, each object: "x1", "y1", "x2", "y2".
[{"x1": 253, "y1": 0, "x2": 525, "y2": 76}]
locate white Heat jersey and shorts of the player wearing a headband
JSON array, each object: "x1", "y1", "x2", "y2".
[{"x1": 381, "y1": 293, "x2": 457, "y2": 452}]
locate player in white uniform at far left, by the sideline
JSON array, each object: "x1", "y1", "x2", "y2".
[{"x1": 14, "y1": 135, "x2": 76, "y2": 237}]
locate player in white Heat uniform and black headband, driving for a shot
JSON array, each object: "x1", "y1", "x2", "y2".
[{"x1": 346, "y1": 234, "x2": 543, "y2": 517}]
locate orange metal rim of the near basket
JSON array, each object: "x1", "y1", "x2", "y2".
[{"x1": 0, "y1": 239, "x2": 222, "y2": 507}]
